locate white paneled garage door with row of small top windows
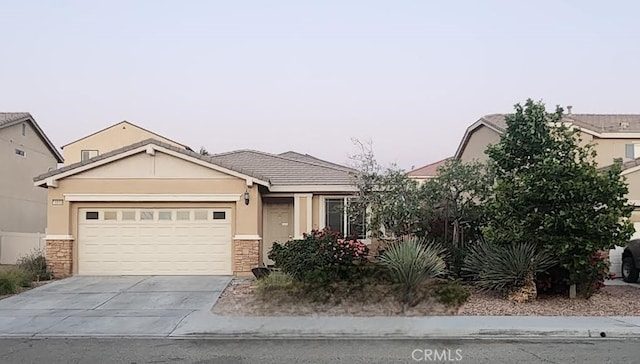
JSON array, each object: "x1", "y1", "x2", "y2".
[{"x1": 78, "y1": 209, "x2": 232, "y2": 275}]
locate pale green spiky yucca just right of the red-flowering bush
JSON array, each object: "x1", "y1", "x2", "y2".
[{"x1": 378, "y1": 237, "x2": 446, "y2": 306}]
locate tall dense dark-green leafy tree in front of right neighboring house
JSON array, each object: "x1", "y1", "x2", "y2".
[{"x1": 484, "y1": 99, "x2": 633, "y2": 296}]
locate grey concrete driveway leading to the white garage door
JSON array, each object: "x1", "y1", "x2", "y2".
[{"x1": 0, "y1": 276, "x2": 231, "y2": 337}]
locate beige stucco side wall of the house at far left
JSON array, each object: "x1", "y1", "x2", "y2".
[{"x1": 0, "y1": 122, "x2": 58, "y2": 233}]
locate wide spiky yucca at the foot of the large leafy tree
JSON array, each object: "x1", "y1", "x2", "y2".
[{"x1": 462, "y1": 242, "x2": 557, "y2": 293}]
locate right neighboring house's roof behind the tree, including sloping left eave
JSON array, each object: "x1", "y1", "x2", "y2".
[{"x1": 455, "y1": 114, "x2": 640, "y2": 158}]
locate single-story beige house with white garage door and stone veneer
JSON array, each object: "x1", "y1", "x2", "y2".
[{"x1": 34, "y1": 138, "x2": 365, "y2": 276}]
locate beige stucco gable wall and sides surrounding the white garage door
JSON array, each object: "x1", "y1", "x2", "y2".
[{"x1": 47, "y1": 152, "x2": 261, "y2": 237}]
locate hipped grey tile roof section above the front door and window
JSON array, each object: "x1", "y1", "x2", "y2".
[{"x1": 209, "y1": 150, "x2": 356, "y2": 186}]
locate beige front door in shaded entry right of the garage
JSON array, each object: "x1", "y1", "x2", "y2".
[{"x1": 262, "y1": 197, "x2": 293, "y2": 266}]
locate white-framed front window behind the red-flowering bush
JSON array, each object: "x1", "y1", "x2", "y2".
[{"x1": 324, "y1": 197, "x2": 366, "y2": 239}]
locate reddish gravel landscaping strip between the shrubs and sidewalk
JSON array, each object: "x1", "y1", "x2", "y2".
[{"x1": 212, "y1": 279, "x2": 640, "y2": 316}]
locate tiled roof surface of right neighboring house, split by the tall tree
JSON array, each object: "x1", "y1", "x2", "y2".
[{"x1": 480, "y1": 114, "x2": 640, "y2": 133}]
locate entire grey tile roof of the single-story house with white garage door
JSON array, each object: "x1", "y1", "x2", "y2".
[{"x1": 34, "y1": 139, "x2": 352, "y2": 191}]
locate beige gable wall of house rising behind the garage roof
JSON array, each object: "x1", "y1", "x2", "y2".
[{"x1": 62, "y1": 122, "x2": 183, "y2": 165}]
